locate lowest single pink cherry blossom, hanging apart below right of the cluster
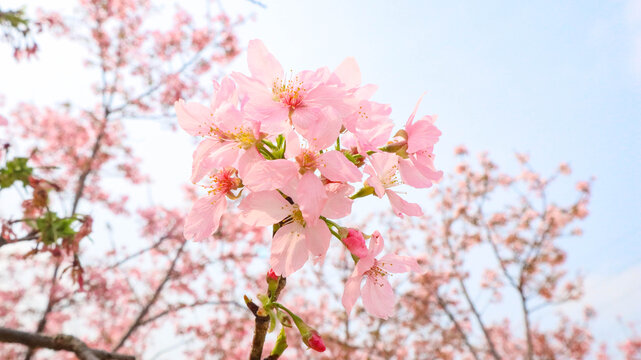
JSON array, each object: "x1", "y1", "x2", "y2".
[{"x1": 342, "y1": 231, "x2": 421, "y2": 319}]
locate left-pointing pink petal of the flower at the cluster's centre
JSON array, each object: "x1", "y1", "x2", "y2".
[{"x1": 242, "y1": 159, "x2": 298, "y2": 191}]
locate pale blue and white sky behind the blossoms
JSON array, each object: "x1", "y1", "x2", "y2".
[{"x1": 0, "y1": 0, "x2": 641, "y2": 354}]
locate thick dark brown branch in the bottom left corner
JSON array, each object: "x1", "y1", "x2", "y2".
[{"x1": 0, "y1": 327, "x2": 136, "y2": 360}]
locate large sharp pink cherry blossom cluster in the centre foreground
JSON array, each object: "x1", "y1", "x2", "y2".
[{"x1": 175, "y1": 40, "x2": 442, "y2": 318}]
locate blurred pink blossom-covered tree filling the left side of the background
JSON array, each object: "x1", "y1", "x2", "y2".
[{"x1": 0, "y1": 0, "x2": 244, "y2": 359}]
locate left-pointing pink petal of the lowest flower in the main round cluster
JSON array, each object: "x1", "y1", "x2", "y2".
[{"x1": 238, "y1": 191, "x2": 294, "y2": 226}]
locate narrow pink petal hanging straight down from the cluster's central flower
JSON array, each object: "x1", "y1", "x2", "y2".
[{"x1": 295, "y1": 171, "x2": 327, "y2": 225}]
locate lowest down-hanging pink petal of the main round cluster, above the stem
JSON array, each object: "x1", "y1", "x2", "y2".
[{"x1": 269, "y1": 222, "x2": 309, "y2": 277}]
